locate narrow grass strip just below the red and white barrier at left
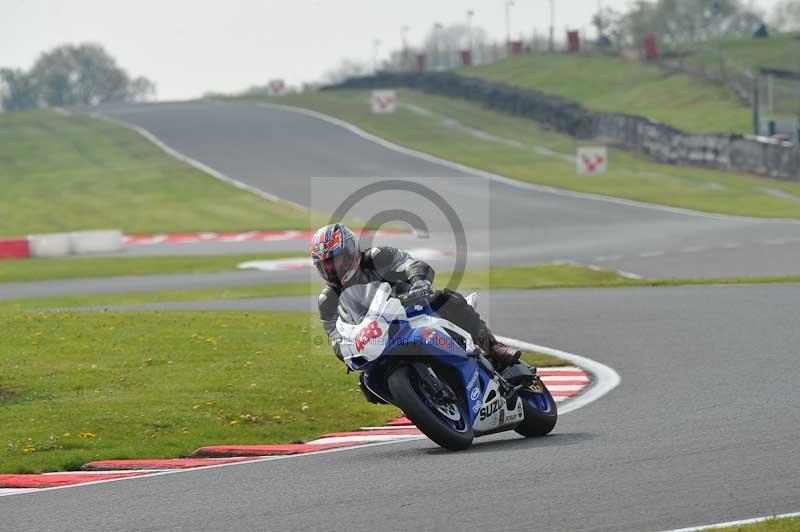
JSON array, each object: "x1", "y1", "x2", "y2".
[{"x1": 0, "y1": 252, "x2": 307, "y2": 283}]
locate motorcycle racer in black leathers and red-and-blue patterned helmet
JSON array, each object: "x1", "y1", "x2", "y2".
[{"x1": 311, "y1": 223, "x2": 521, "y2": 366}]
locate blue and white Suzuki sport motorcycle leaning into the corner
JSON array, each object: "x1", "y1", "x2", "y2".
[{"x1": 336, "y1": 282, "x2": 558, "y2": 451}]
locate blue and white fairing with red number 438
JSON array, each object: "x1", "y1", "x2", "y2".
[{"x1": 336, "y1": 283, "x2": 524, "y2": 434}]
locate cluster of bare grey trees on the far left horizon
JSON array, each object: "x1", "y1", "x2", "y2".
[{"x1": 0, "y1": 43, "x2": 156, "y2": 110}]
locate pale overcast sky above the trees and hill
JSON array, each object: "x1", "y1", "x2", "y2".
[{"x1": 0, "y1": 0, "x2": 778, "y2": 99}]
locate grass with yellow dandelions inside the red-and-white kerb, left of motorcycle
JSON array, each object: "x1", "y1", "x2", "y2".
[{"x1": 0, "y1": 312, "x2": 398, "y2": 473}]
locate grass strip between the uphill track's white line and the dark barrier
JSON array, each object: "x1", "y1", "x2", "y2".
[{"x1": 234, "y1": 90, "x2": 800, "y2": 218}]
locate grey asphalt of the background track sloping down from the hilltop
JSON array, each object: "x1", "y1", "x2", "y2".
[{"x1": 97, "y1": 98, "x2": 800, "y2": 277}]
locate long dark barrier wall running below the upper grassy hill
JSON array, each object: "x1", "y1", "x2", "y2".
[{"x1": 324, "y1": 72, "x2": 800, "y2": 181}]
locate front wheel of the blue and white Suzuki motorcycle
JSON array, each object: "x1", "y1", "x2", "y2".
[{"x1": 387, "y1": 366, "x2": 473, "y2": 451}]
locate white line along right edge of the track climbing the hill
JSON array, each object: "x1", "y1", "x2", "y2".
[{"x1": 252, "y1": 102, "x2": 800, "y2": 224}]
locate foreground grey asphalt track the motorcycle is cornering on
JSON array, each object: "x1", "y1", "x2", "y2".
[{"x1": 0, "y1": 285, "x2": 800, "y2": 532}]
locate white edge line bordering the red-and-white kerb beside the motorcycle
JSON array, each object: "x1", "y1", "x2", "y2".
[{"x1": 0, "y1": 336, "x2": 620, "y2": 499}]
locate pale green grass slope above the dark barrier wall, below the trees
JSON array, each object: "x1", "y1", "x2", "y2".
[{"x1": 458, "y1": 54, "x2": 752, "y2": 133}]
